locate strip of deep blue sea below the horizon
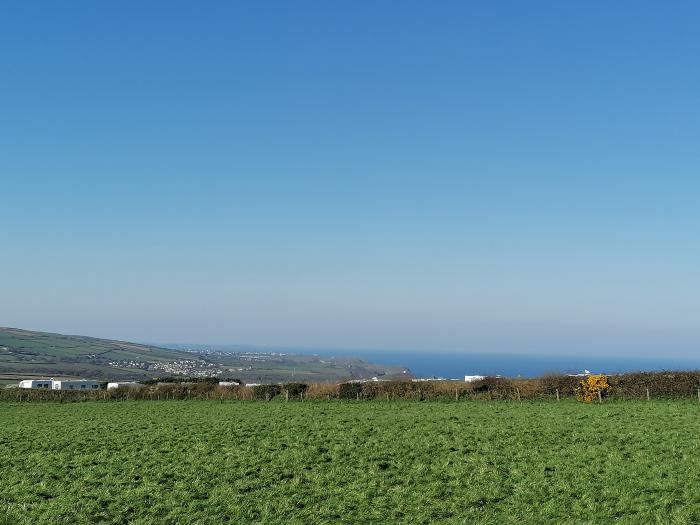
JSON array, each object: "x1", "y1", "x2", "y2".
[{"x1": 308, "y1": 350, "x2": 700, "y2": 379}]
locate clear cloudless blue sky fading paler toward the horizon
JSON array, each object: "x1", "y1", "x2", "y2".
[{"x1": 0, "y1": 0, "x2": 700, "y2": 356}]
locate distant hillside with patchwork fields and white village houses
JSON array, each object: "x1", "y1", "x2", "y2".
[{"x1": 0, "y1": 327, "x2": 411, "y2": 383}]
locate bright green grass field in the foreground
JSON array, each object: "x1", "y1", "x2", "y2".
[{"x1": 0, "y1": 401, "x2": 700, "y2": 525}]
